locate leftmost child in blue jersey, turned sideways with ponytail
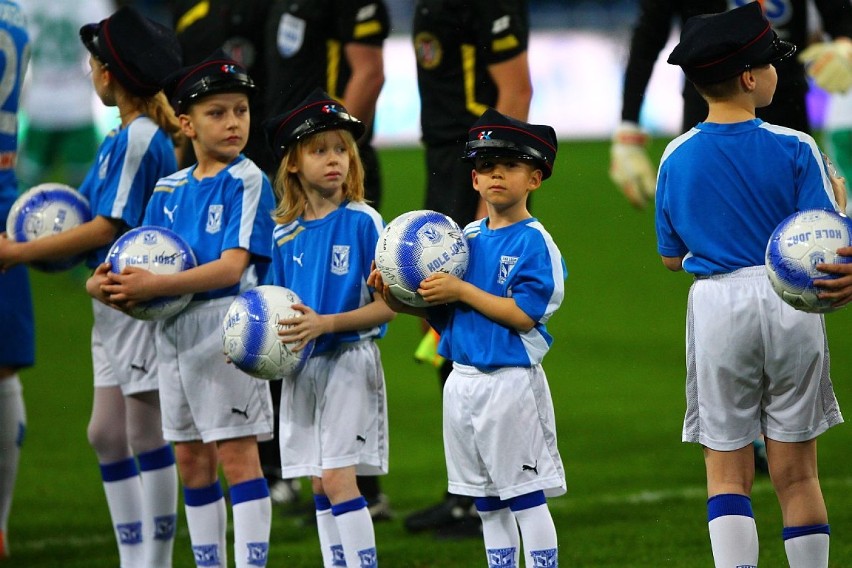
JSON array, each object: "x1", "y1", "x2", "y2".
[{"x1": 0, "y1": 8, "x2": 180, "y2": 567}]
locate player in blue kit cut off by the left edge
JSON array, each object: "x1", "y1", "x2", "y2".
[{"x1": 0, "y1": 0, "x2": 28, "y2": 561}]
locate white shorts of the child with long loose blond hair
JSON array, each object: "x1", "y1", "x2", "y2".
[{"x1": 279, "y1": 340, "x2": 388, "y2": 479}]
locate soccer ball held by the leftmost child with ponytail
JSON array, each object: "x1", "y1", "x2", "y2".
[{"x1": 6, "y1": 183, "x2": 92, "y2": 272}]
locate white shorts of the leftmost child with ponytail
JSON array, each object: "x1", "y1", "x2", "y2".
[{"x1": 92, "y1": 300, "x2": 158, "y2": 396}]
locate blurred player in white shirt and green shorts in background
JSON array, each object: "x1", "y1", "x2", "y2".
[{"x1": 18, "y1": 0, "x2": 114, "y2": 191}]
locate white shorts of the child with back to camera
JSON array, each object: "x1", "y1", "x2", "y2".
[{"x1": 683, "y1": 266, "x2": 843, "y2": 451}]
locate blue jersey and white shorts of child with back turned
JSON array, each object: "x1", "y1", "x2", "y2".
[{"x1": 656, "y1": 119, "x2": 843, "y2": 451}]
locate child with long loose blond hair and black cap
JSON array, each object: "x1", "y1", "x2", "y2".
[{"x1": 265, "y1": 89, "x2": 395, "y2": 568}]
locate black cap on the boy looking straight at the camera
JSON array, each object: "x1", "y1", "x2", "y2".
[{"x1": 462, "y1": 108, "x2": 558, "y2": 179}]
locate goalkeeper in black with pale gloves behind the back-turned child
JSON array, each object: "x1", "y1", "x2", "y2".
[{"x1": 610, "y1": 0, "x2": 852, "y2": 209}]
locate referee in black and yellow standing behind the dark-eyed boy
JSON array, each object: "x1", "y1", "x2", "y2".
[{"x1": 405, "y1": 0, "x2": 532, "y2": 538}]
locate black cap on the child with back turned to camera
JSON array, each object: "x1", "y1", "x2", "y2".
[{"x1": 668, "y1": 2, "x2": 796, "y2": 87}]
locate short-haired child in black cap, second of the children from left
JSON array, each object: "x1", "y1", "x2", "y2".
[{"x1": 95, "y1": 52, "x2": 274, "y2": 568}]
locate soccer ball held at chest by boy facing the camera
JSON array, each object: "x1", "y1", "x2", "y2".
[{"x1": 375, "y1": 210, "x2": 469, "y2": 308}]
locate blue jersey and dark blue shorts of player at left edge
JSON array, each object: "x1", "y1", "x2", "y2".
[{"x1": 0, "y1": 0, "x2": 35, "y2": 368}]
